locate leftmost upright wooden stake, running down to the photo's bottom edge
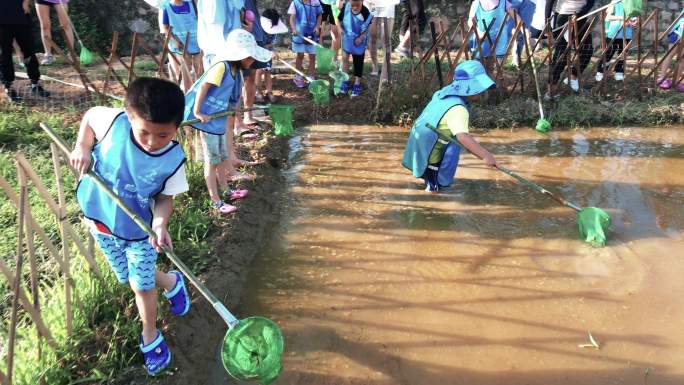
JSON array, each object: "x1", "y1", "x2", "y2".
[{"x1": 7, "y1": 167, "x2": 28, "y2": 384}]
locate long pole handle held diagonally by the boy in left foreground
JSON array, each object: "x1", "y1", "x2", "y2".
[{"x1": 40, "y1": 123, "x2": 239, "y2": 329}]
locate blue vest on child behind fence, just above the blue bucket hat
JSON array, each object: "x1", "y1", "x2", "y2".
[{"x1": 470, "y1": 0, "x2": 511, "y2": 58}]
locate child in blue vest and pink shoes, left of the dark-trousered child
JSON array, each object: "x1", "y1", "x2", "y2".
[{"x1": 287, "y1": 0, "x2": 323, "y2": 88}]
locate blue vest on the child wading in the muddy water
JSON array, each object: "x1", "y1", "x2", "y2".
[{"x1": 401, "y1": 86, "x2": 466, "y2": 186}]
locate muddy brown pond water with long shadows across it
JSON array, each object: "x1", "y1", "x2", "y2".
[{"x1": 217, "y1": 126, "x2": 684, "y2": 385}]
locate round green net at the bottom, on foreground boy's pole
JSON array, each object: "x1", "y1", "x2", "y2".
[{"x1": 221, "y1": 317, "x2": 285, "y2": 385}]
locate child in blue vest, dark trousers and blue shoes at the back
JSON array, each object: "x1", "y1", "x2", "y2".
[{"x1": 337, "y1": 0, "x2": 373, "y2": 97}]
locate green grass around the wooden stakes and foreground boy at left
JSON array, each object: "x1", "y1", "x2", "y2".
[{"x1": 0, "y1": 106, "x2": 212, "y2": 385}]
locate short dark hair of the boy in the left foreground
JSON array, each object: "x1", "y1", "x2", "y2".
[{"x1": 124, "y1": 77, "x2": 185, "y2": 125}]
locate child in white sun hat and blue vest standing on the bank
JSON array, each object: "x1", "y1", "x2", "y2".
[{"x1": 185, "y1": 29, "x2": 272, "y2": 214}]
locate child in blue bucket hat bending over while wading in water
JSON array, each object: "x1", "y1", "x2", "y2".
[{"x1": 402, "y1": 60, "x2": 497, "y2": 193}]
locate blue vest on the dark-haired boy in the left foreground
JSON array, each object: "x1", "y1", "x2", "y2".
[{"x1": 76, "y1": 112, "x2": 185, "y2": 241}]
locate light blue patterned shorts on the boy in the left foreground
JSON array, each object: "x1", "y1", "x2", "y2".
[{"x1": 93, "y1": 232, "x2": 157, "y2": 291}]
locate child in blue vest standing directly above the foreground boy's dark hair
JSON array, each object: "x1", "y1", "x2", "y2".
[{"x1": 159, "y1": 0, "x2": 202, "y2": 90}]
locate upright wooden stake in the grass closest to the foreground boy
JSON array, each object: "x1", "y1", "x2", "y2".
[{"x1": 50, "y1": 143, "x2": 74, "y2": 335}]
